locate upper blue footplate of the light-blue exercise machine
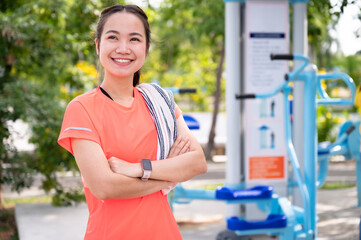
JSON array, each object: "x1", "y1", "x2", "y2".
[{"x1": 216, "y1": 186, "x2": 273, "y2": 200}]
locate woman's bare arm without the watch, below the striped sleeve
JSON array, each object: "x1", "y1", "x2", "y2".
[{"x1": 72, "y1": 139, "x2": 174, "y2": 199}]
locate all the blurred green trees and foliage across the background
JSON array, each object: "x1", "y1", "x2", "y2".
[{"x1": 0, "y1": 0, "x2": 361, "y2": 207}]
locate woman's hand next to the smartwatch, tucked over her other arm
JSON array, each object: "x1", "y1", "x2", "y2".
[{"x1": 108, "y1": 157, "x2": 143, "y2": 177}]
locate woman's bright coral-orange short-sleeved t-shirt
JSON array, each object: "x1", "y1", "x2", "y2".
[{"x1": 58, "y1": 87, "x2": 182, "y2": 240}]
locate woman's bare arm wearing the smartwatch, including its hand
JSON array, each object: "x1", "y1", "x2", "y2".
[{"x1": 109, "y1": 116, "x2": 207, "y2": 182}]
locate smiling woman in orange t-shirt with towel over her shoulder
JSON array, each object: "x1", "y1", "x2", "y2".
[{"x1": 58, "y1": 5, "x2": 207, "y2": 240}]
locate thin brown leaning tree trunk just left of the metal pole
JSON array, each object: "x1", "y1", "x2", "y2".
[{"x1": 205, "y1": 43, "x2": 224, "y2": 160}]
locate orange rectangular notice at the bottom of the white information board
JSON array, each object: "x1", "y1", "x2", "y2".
[{"x1": 248, "y1": 156, "x2": 285, "y2": 180}]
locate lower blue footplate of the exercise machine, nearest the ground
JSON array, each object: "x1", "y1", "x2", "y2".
[{"x1": 227, "y1": 214, "x2": 287, "y2": 231}]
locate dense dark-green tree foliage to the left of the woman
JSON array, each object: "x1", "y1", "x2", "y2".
[{"x1": 0, "y1": 0, "x2": 114, "y2": 204}]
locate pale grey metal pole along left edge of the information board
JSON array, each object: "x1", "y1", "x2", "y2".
[{"x1": 225, "y1": 2, "x2": 241, "y2": 216}]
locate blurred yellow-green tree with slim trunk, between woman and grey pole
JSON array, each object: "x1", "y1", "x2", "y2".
[{"x1": 148, "y1": 0, "x2": 224, "y2": 159}]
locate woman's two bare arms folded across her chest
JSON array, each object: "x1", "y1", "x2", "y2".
[{"x1": 72, "y1": 116, "x2": 207, "y2": 199}]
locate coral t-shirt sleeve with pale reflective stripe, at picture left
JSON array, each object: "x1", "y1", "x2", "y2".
[{"x1": 58, "y1": 100, "x2": 100, "y2": 154}]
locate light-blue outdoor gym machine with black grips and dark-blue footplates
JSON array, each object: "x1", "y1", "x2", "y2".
[{"x1": 170, "y1": 55, "x2": 361, "y2": 240}]
